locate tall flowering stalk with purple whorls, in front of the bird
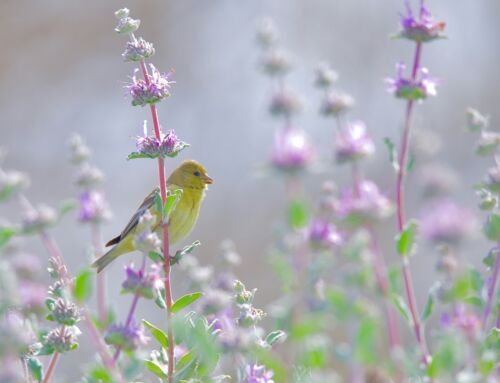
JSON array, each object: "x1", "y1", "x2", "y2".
[{"x1": 115, "y1": 8, "x2": 187, "y2": 382}]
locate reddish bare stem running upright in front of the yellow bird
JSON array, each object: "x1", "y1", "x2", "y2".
[{"x1": 141, "y1": 60, "x2": 175, "y2": 383}]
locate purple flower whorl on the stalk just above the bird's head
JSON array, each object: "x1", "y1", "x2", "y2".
[{"x1": 129, "y1": 121, "x2": 189, "y2": 159}]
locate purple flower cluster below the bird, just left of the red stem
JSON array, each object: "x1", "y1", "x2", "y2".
[{"x1": 122, "y1": 263, "x2": 162, "y2": 299}]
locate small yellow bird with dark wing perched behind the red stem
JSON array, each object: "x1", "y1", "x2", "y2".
[{"x1": 92, "y1": 160, "x2": 213, "y2": 272}]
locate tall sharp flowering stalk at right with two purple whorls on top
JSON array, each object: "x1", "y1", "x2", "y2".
[{"x1": 388, "y1": 0, "x2": 445, "y2": 366}]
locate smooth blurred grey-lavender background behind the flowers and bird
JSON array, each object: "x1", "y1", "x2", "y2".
[{"x1": 0, "y1": 0, "x2": 500, "y2": 378}]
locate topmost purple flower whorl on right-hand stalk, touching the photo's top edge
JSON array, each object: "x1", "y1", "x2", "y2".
[{"x1": 397, "y1": 0, "x2": 446, "y2": 42}]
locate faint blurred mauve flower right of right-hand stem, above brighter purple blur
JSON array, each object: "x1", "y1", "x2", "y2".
[{"x1": 420, "y1": 163, "x2": 459, "y2": 197}]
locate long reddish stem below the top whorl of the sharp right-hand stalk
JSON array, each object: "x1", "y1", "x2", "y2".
[{"x1": 396, "y1": 42, "x2": 431, "y2": 367}]
